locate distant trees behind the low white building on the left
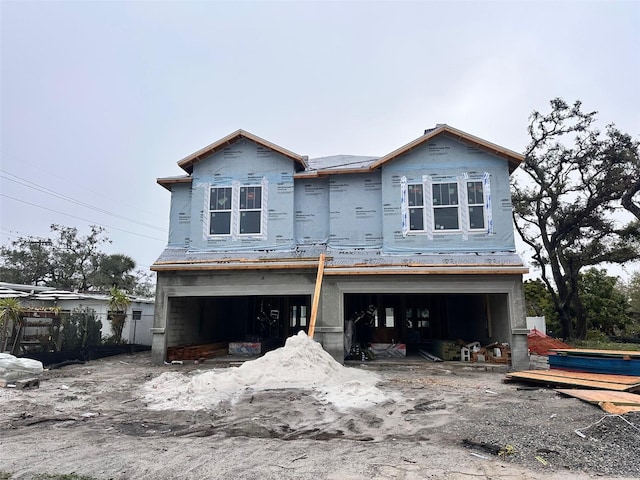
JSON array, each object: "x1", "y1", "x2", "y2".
[{"x1": 0, "y1": 225, "x2": 153, "y2": 296}]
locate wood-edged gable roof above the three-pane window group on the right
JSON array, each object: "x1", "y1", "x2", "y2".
[{"x1": 369, "y1": 124, "x2": 524, "y2": 173}]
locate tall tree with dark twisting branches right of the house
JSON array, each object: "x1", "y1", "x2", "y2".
[{"x1": 512, "y1": 99, "x2": 640, "y2": 338}]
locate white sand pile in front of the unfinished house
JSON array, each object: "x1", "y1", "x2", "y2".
[{"x1": 143, "y1": 331, "x2": 391, "y2": 410}]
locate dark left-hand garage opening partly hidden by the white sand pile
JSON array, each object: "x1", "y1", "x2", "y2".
[{"x1": 167, "y1": 295, "x2": 311, "y2": 360}]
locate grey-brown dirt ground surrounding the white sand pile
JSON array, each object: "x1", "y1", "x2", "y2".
[{"x1": 0, "y1": 352, "x2": 640, "y2": 480}]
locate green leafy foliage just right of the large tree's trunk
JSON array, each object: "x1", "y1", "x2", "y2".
[{"x1": 580, "y1": 268, "x2": 631, "y2": 336}]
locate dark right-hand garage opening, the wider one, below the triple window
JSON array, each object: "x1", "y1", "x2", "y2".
[{"x1": 344, "y1": 293, "x2": 511, "y2": 360}]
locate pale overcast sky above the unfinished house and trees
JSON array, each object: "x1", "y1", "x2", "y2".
[{"x1": 0, "y1": 0, "x2": 640, "y2": 282}]
